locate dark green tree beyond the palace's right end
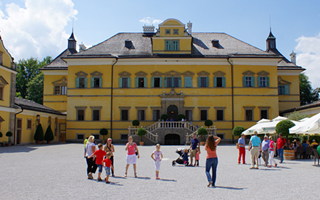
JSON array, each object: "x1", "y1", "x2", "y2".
[{"x1": 299, "y1": 73, "x2": 319, "y2": 105}]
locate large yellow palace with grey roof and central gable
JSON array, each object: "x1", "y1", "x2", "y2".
[{"x1": 42, "y1": 19, "x2": 304, "y2": 144}]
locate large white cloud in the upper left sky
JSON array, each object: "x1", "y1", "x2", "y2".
[{"x1": 0, "y1": 0, "x2": 78, "y2": 62}]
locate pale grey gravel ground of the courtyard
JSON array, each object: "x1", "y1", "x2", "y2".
[{"x1": 0, "y1": 144, "x2": 320, "y2": 200}]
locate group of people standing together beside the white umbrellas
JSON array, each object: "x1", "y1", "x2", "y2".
[{"x1": 238, "y1": 131, "x2": 287, "y2": 169}]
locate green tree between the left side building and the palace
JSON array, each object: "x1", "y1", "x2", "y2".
[{"x1": 16, "y1": 56, "x2": 52, "y2": 102}]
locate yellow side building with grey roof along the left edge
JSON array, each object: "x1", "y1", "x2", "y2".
[{"x1": 0, "y1": 36, "x2": 66, "y2": 144}]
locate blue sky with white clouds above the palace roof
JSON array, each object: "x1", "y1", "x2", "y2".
[{"x1": 0, "y1": 0, "x2": 320, "y2": 88}]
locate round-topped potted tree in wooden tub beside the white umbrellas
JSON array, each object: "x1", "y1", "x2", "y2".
[{"x1": 276, "y1": 120, "x2": 295, "y2": 160}]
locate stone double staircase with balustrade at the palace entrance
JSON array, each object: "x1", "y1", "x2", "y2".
[{"x1": 128, "y1": 121, "x2": 216, "y2": 144}]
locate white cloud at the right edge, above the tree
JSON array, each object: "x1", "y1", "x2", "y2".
[{"x1": 295, "y1": 33, "x2": 320, "y2": 88}]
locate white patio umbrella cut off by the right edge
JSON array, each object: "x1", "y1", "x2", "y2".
[{"x1": 289, "y1": 113, "x2": 320, "y2": 134}]
